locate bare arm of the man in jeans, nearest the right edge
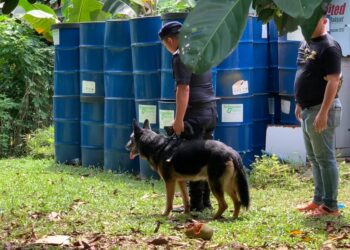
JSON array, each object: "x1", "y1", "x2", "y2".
[{"x1": 313, "y1": 74, "x2": 340, "y2": 133}]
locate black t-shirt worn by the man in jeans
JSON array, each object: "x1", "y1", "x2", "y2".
[{"x1": 294, "y1": 34, "x2": 342, "y2": 108}]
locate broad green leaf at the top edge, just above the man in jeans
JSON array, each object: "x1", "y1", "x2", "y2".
[{"x1": 273, "y1": 0, "x2": 322, "y2": 19}]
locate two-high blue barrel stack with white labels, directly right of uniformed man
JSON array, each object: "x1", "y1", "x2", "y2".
[{"x1": 214, "y1": 18, "x2": 254, "y2": 165}]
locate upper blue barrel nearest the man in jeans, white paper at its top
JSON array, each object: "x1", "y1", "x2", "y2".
[{"x1": 278, "y1": 31, "x2": 303, "y2": 95}]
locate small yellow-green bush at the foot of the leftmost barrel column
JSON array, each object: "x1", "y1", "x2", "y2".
[{"x1": 27, "y1": 126, "x2": 54, "y2": 159}]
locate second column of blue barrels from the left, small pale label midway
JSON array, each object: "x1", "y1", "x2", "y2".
[{"x1": 80, "y1": 22, "x2": 105, "y2": 167}]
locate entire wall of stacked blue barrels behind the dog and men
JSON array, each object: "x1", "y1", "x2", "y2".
[{"x1": 52, "y1": 16, "x2": 302, "y2": 171}]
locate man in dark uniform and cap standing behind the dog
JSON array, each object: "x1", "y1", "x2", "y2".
[{"x1": 158, "y1": 21, "x2": 217, "y2": 211}]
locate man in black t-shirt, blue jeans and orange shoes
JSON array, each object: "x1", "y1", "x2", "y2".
[{"x1": 294, "y1": 16, "x2": 341, "y2": 217}]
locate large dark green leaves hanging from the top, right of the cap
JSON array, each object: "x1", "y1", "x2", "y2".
[{"x1": 180, "y1": 0, "x2": 331, "y2": 73}]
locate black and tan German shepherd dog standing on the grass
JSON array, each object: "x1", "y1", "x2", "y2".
[{"x1": 126, "y1": 120, "x2": 250, "y2": 219}]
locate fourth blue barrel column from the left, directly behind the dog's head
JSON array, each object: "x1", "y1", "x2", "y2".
[{"x1": 130, "y1": 16, "x2": 161, "y2": 178}]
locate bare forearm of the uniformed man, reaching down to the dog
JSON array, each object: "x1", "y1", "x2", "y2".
[{"x1": 173, "y1": 84, "x2": 190, "y2": 135}]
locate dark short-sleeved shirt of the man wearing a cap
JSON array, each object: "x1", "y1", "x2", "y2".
[{"x1": 173, "y1": 51, "x2": 215, "y2": 105}]
